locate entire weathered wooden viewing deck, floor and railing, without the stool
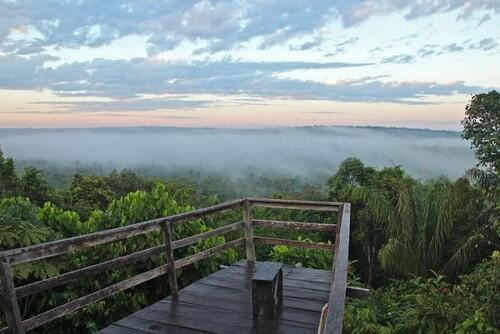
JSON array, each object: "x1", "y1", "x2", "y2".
[{"x1": 0, "y1": 198, "x2": 360, "y2": 334}]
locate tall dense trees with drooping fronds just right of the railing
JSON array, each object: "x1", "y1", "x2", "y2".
[{"x1": 329, "y1": 158, "x2": 495, "y2": 286}]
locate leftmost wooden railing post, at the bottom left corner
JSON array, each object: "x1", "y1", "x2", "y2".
[{"x1": 0, "y1": 261, "x2": 25, "y2": 334}]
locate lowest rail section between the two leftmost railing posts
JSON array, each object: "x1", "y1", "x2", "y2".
[{"x1": 23, "y1": 265, "x2": 167, "y2": 330}]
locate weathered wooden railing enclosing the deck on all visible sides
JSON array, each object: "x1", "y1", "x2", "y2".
[{"x1": 0, "y1": 198, "x2": 356, "y2": 334}]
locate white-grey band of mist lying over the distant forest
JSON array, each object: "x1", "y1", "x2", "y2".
[{"x1": 0, "y1": 126, "x2": 475, "y2": 183}]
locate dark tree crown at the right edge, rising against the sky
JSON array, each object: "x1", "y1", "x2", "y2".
[{"x1": 462, "y1": 90, "x2": 500, "y2": 174}]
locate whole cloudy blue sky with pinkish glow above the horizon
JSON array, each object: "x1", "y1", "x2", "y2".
[{"x1": 0, "y1": 0, "x2": 500, "y2": 130}]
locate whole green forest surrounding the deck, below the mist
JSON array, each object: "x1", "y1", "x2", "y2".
[{"x1": 0, "y1": 91, "x2": 500, "y2": 334}]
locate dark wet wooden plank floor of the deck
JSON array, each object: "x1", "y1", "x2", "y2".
[{"x1": 99, "y1": 260, "x2": 331, "y2": 334}]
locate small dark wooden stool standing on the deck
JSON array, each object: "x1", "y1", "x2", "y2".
[{"x1": 252, "y1": 262, "x2": 283, "y2": 319}]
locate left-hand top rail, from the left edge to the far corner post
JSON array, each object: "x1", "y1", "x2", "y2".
[{"x1": 0, "y1": 199, "x2": 243, "y2": 264}]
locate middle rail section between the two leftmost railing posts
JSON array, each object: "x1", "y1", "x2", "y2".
[{"x1": 16, "y1": 245, "x2": 165, "y2": 298}]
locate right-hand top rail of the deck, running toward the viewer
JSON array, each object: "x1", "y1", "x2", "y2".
[{"x1": 325, "y1": 203, "x2": 351, "y2": 334}]
